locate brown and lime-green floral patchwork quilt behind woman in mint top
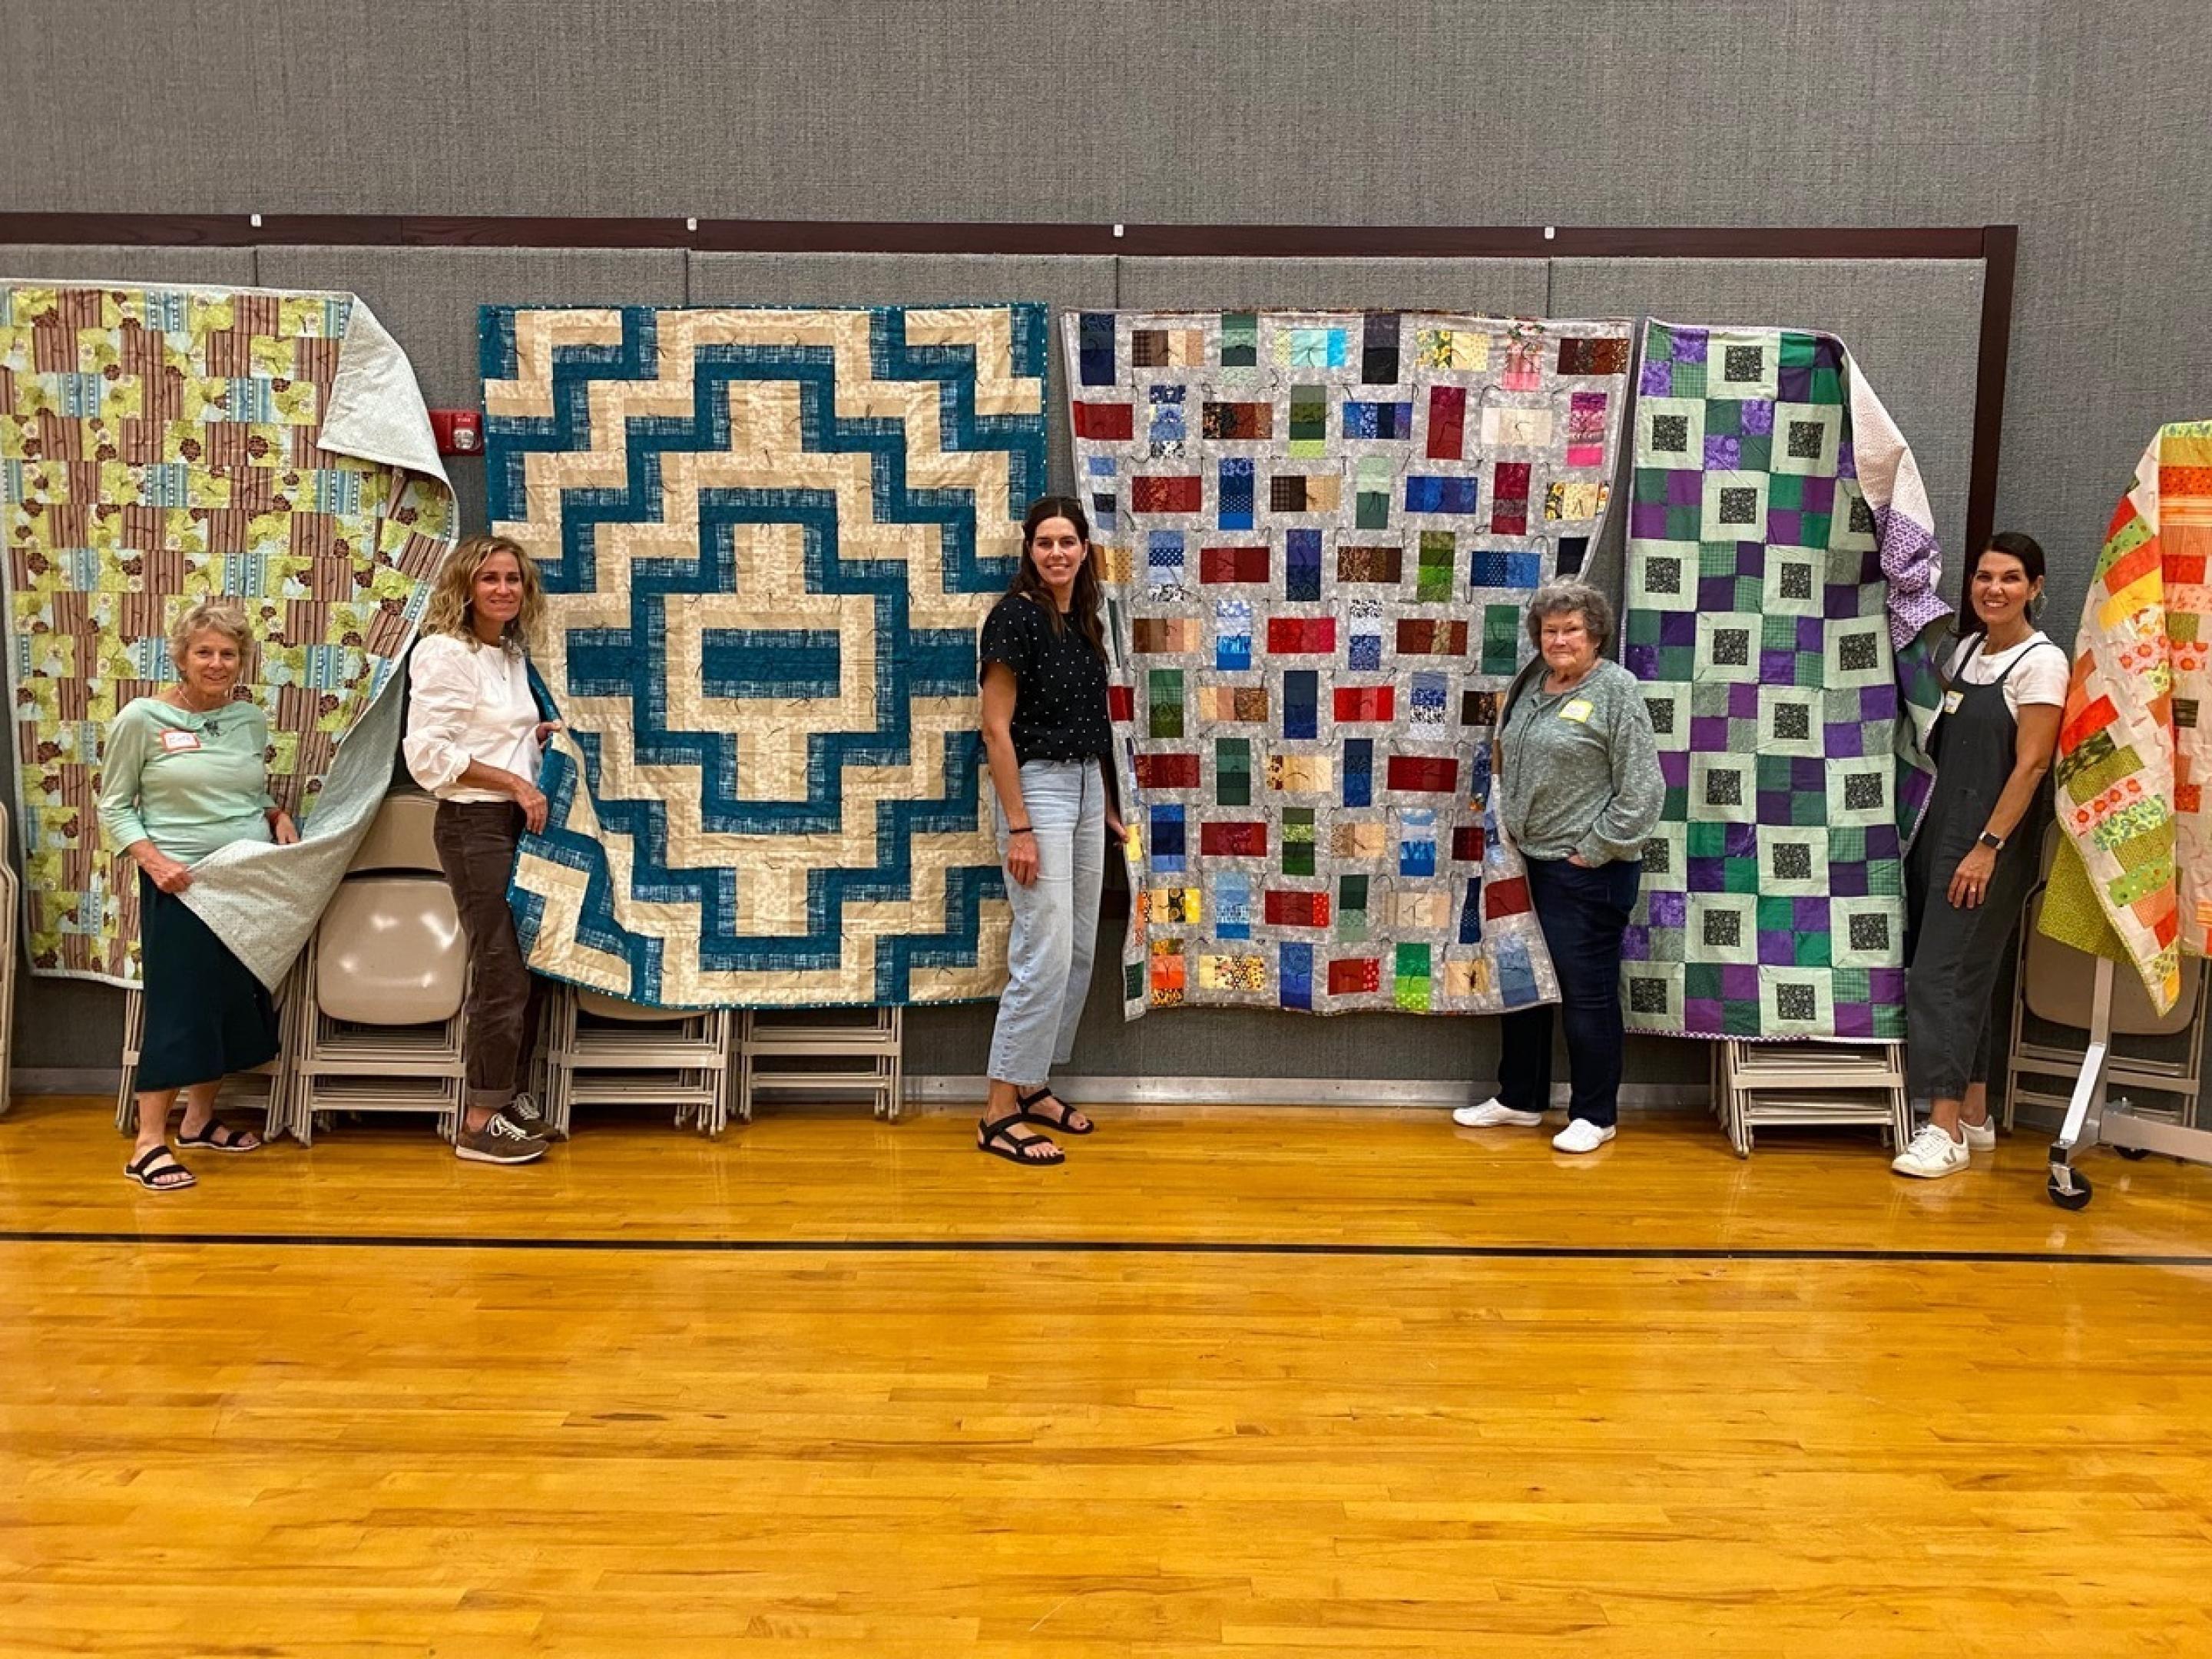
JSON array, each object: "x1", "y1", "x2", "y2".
[{"x1": 0, "y1": 283, "x2": 453, "y2": 985}]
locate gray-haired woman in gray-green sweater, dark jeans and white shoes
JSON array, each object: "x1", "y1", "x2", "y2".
[{"x1": 1453, "y1": 581, "x2": 1666, "y2": 1152}]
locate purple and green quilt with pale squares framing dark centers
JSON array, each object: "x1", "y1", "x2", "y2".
[{"x1": 1621, "y1": 321, "x2": 1949, "y2": 1040}]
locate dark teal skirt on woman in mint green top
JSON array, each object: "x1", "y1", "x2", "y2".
[{"x1": 135, "y1": 872, "x2": 279, "y2": 1091}]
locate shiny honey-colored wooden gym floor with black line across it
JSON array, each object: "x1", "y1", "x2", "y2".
[{"x1": 0, "y1": 1099, "x2": 2212, "y2": 1659}]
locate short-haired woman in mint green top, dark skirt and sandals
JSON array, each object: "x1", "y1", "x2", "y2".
[{"x1": 100, "y1": 599, "x2": 299, "y2": 1192}]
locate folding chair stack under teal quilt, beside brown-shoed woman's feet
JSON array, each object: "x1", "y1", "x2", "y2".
[{"x1": 544, "y1": 985, "x2": 743, "y2": 1137}]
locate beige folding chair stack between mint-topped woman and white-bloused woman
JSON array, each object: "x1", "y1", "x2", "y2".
[{"x1": 286, "y1": 790, "x2": 469, "y2": 1144}]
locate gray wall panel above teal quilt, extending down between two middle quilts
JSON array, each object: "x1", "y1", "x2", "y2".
[{"x1": 690, "y1": 254, "x2": 1115, "y2": 491}]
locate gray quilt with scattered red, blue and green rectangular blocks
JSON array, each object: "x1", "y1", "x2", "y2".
[{"x1": 1064, "y1": 312, "x2": 1631, "y2": 1020}]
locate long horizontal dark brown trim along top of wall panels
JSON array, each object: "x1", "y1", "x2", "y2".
[{"x1": 0, "y1": 212, "x2": 1986, "y2": 259}]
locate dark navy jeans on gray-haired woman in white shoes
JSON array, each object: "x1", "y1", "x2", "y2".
[{"x1": 1498, "y1": 858, "x2": 1644, "y2": 1128}]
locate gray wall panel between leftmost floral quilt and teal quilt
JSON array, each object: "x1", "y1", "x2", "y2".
[{"x1": 261, "y1": 248, "x2": 684, "y2": 409}]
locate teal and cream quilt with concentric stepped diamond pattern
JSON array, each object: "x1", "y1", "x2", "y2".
[{"x1": 482, "y1": 305, "x2": 1046, "y2": 1006}]
